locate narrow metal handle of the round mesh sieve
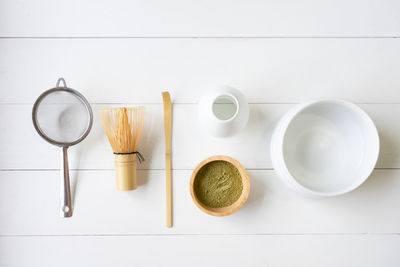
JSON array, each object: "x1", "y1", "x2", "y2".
[{"x1": 60, "y1": 147, "x2": 72, "y2": 217}]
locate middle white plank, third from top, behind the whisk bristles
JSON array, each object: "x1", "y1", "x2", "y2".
[{"x1": 0, "y1": 104, "x2": 400, "y2": 170}]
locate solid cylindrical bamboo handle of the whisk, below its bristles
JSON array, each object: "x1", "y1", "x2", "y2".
[{"x1": 114, "y1": 154, "x2": 137, "y2": 191}]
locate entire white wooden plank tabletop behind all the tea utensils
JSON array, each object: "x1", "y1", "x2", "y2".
[{"x1": 0, "y1": 0, "x2": 400, "y2": 266}]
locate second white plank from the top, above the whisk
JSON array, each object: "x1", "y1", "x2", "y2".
[{"x1": 0, "y1": 39, "x2": 400, "y2": 103}]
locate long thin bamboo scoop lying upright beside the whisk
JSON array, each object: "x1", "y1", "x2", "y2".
[{"x1": 162, "y1": 92, "x2": 172, "y2": 227}]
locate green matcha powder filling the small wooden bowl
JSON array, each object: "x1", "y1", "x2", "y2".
[{"x1": 194, "y1": 160, "x2": 243, "y2": 208}]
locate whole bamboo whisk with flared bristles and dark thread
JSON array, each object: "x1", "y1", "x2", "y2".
[{"x1": 100, "y1": 107, "x2": 146, "y2": 191}]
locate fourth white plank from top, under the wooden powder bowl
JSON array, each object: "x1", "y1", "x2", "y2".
[{"x1": 0, "y1": 170, "x2": 400, "y2": 235}]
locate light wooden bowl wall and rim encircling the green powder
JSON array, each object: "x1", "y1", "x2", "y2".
[{"x1": 190, "y1": 156, "x2": 250, "y2": 216}]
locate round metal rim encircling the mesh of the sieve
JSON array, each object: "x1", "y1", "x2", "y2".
[{"x1": 32, "y1": 85, "x2": 93, "y2": 147}]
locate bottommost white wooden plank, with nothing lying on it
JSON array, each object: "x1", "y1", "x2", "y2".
[{"x1": 0, "y1": 235, "x2": 400, "y2": 267}]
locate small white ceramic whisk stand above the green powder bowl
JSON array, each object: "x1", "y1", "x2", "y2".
[{"x1": 198, "y1": 86, "x2": 249, "y2": 137}]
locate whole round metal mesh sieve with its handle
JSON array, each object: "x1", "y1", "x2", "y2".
[{"x1": 32, "y1": 78, "x2": 93, "y2": 217}]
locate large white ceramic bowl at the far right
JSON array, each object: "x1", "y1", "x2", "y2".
[{"x1": 271, "y1": 100, "x2": 379, "y2": 196}]
